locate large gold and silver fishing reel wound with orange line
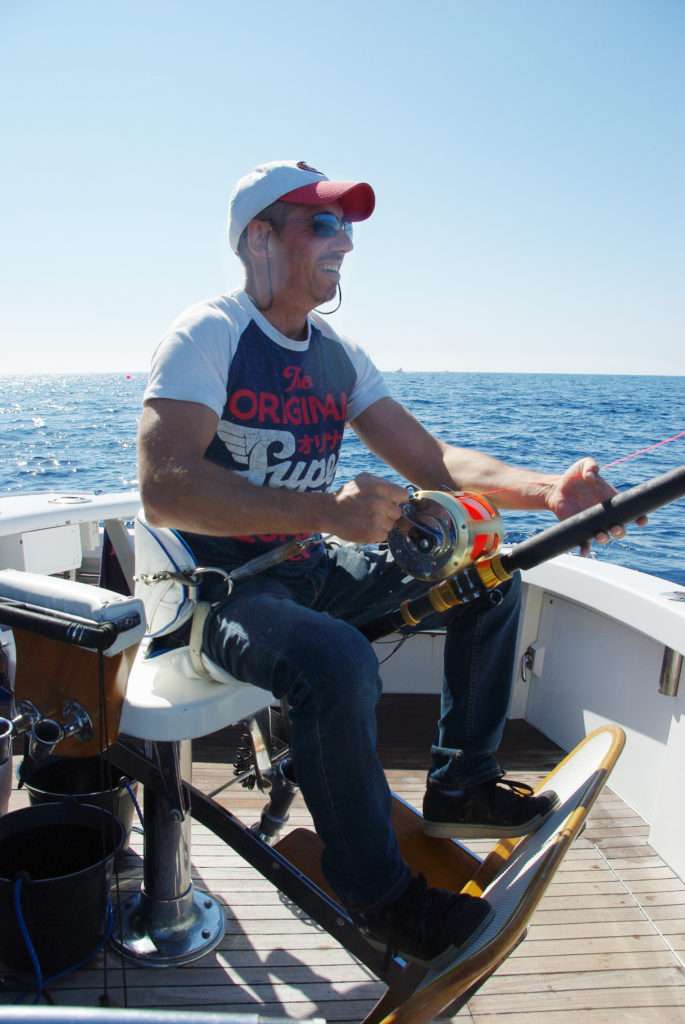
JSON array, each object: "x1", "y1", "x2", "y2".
[{"x1": 388, "y1": 488, "x2": 504, "y2": 582}]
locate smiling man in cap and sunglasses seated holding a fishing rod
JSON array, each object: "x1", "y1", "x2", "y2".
[{"x1": 139, "y1": 161, "x2": 622, "y2": 966}]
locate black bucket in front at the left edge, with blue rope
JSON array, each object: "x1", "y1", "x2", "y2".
[{"x1": 0, "y1": 802, "x2": 124, "y2": 979}]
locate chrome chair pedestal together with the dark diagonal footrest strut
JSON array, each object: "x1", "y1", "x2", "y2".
[{"x1": 105, "y1": 740, "x2": 425, "y2": 994}]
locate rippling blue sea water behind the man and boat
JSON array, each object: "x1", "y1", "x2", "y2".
[{"x1": 0, "y1": 372, "x2": 685, "y2": 585}]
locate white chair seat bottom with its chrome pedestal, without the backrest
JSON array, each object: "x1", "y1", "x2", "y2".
[{"x1": 113, "y1": 643, "x2": 268, "y2": 967}]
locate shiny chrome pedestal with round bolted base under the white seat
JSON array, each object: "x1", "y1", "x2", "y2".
[{"x1": 112, "y1": 739, "x2": 225, "y2": 967}]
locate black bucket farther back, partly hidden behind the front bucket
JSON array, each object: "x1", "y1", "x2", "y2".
[{"x1": 24, "y1": 757, "x2": 137, "y2": 845}]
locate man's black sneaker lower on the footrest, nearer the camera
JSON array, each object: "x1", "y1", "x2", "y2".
[{"x1": 356, "y1": 874, "x2": 495, "y2": 969}]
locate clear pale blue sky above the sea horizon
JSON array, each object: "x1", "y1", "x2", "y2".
[{"x1": 0, "y1": 0, "x2": 685, "y2": 375}]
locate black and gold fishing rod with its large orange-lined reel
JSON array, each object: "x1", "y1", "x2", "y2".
[{"x1": 355, "y1": 465, "x2": 685, "y2": 641}]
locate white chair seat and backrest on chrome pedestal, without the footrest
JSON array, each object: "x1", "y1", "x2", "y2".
[{"x1": 109, "y1": 513, "x2": 271, "y2": 966}]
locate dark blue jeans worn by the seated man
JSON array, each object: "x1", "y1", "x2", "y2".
[{"x1": 204, "y1": 546, "x2": 520, "y2": 909}]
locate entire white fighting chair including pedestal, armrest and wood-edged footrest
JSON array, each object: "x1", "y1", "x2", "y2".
[{"x1": 0, "y1": 536, "x2": 624, "y2": 1024}]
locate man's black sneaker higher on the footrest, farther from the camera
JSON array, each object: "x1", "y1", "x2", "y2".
[{"x1": 423, "y1": 778, "x2": 559, "y2": 839}]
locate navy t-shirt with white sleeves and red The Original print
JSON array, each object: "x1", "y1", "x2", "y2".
[{"x1": 145, "y1": 291, "x2": 389, "y2": 577}]
